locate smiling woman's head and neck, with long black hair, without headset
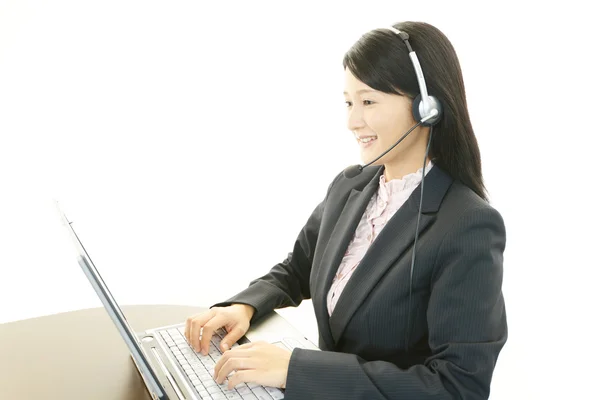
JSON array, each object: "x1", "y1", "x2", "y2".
[{"x1": 343, "y1": 23, "x2": 486, "y2": 198}]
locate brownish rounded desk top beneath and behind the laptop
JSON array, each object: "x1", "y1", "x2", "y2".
[{"x1": 0, "y1": 305, "x2": 206, "y2": 400}]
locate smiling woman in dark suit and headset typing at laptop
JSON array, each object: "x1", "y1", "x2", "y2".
[{"x1": 185, "y1": 22, "x2": 507, "y2": 400}]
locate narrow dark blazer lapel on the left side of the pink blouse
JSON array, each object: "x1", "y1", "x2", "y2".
[{"x1": 313, "y1": 167, "x2": 383, "y2": 349}]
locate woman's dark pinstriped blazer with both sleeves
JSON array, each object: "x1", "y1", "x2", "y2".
[{"x1": 213, "y1": 165, "x2": 507, "y2": 400}]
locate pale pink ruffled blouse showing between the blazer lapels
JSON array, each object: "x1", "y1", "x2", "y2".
[{"x1": 327, "y1": 161, "x2": 433, "y2": 316}]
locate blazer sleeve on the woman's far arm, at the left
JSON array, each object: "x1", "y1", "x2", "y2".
[{"x1": 210, "y1": 172, "x2": 342, "y2": 324}]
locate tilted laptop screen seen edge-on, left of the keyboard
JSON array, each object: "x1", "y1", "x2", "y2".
[{"x1": 56, "y1": 204, "x2": 168, "y2": 399}]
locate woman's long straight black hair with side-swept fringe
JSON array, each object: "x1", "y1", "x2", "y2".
[{"x1": 343, "y1": 21, "x2": 488, "y2": 201}]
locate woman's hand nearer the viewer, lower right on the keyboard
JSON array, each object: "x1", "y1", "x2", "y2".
[{"x1": 213, "y1": 342, "x2": 292, "y2": 389}]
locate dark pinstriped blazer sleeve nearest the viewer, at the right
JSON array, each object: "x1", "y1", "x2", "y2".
[{"x1": 285, "y1": 207, "x2": 507, "y2": 400}]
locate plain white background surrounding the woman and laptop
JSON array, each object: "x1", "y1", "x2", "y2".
[{"x1": 0, "y1": 0, "x2": 600, "y2": 400}]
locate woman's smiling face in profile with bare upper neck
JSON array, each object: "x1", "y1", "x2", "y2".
[{"x1": 344, "y1": 68, "x2": 427, "y2": 165}]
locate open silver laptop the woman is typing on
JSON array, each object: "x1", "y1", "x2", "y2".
[{"x1": 55, "y1": 202, "x2": 319, "y2": 400}]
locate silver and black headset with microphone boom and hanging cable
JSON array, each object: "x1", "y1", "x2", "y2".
[{"x1": 344, "y1": 27, "x2": 442, "y2": 351}]
